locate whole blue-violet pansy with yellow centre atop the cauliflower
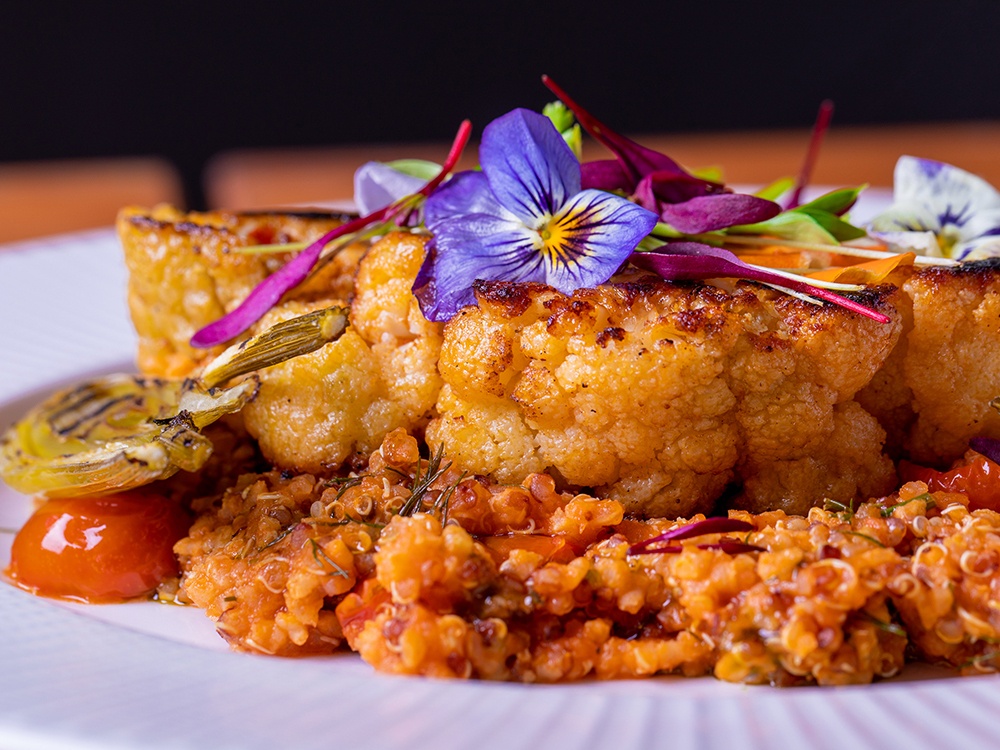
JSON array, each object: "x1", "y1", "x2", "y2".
[{"x1": 413, "y1": 109, "x2": 657, "y2": 321}]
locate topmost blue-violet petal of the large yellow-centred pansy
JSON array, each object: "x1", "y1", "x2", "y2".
[{"x1": 479, "y1": 109, "x2": 580, "y2": 227}]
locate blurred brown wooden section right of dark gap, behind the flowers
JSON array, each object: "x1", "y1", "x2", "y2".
[{"x1": 205, "y1": 122, "x2": 1000, "y2": 209}]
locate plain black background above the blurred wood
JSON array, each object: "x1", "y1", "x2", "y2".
[{"x1": 0, "y1": 0, "x2": 1000, "y2": 207}]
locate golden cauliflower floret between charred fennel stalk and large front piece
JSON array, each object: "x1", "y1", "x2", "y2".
[{"x1": 243, "y1": 233, "x2": 441, "y2": 473}]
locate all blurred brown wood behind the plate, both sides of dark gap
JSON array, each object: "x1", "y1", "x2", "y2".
[{"x1": 0, "y1": 122, "x2": 1000, "y2": 242}]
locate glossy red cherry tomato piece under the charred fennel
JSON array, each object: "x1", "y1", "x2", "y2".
[{"x1": 7, "y1": 490, "x2": 189, "y2": 602}]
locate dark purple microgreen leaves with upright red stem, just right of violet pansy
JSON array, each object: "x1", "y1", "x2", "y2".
[{"x1": 542, "y1": 76, "x2": 781, "y2": 234}]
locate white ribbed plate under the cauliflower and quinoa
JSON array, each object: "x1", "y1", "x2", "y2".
[{"x1": 0, "y1": 206, "x2": 1000, "y2": 750}]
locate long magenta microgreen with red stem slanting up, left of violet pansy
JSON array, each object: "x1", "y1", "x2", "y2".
[{"x1": 191, "y1": 120, "x2": 472, "y2": 348}]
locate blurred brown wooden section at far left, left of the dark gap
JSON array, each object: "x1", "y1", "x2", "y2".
[{"x1": 0, "y1": 157, "x2": 184, "y2": 242}]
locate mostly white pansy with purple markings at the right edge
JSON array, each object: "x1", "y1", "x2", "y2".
[{"x1": 868, "y1": 156, "x2": 1000, "y2": 260}]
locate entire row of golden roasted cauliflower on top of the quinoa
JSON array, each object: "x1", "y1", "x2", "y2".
[{"x1": 119, "y1": 214, "x2": 1000, "y2": 516}]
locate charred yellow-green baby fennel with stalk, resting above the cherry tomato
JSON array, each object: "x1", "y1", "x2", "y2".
[{"x1": 0, "y1": 307, "x2": 348, "y2": 498}]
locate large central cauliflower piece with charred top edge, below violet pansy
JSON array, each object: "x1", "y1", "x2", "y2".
[{"x1": 427, "y1": 276, "x2": 900, "y2": 517}]
